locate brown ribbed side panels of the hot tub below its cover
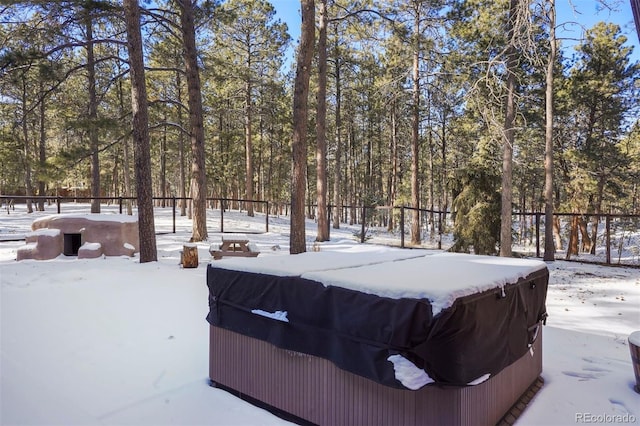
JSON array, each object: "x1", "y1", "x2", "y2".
[{"x1": 209, "y1": 326, "x2": 542, "y2": 425}]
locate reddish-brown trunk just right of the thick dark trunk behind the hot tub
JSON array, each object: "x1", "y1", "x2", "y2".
[{"x1": 316, "y1": 0, "x2": 329, "y2": 241}]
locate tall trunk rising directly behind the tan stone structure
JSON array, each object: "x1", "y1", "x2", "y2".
[{"x1": 85, "y1": 12, "x2": 100, "y2": 213}]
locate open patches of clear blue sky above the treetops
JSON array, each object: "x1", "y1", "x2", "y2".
[{"x1": 270, "y1": 0, "x2": 640, "y2": 62}]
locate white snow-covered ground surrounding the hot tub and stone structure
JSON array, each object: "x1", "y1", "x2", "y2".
[{"x1": 0, "y1": 205, "x2": 640, "y2": 425}]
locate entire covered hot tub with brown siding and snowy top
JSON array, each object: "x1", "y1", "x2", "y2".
[{"x1": 207, "y1": 250, "x2": 548, "y2": 425}]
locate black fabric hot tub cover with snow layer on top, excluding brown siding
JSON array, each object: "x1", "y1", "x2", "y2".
[{"x1": 207, "y1": 251, "x2": 548, "y2": 388}]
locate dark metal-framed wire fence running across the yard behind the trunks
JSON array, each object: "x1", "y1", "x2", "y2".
[{"x1": 0, "y1": 195, "x2": 640, "y2": 266}]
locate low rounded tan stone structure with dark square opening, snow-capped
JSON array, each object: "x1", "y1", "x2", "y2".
[{"x1": 17, "y1": 214, "x2": 140, "y2": 260}]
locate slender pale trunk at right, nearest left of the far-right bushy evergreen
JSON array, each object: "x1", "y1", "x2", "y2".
[{"x1": 544, "y1": 0, "x2": 558, "y2": 262}]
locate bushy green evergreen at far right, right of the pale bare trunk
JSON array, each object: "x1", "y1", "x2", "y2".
[{"x1": 563, "y1": 23, "x2": 640, "y2": 255}]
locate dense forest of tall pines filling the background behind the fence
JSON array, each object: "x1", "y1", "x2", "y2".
[{"x1": 0, "y1": 0, "x2": 640, "y2": 259}]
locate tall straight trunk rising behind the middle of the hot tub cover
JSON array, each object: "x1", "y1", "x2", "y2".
[{"x1": 411, "y1": 5, "x2": 421, "y2": 245}]
